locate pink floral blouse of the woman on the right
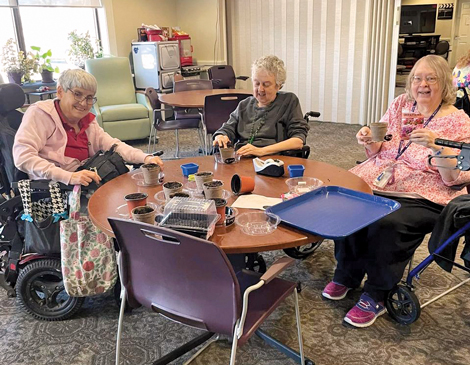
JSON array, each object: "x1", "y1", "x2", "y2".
[{"x1": 350, "y1": 94, "x2": 470, "y2": 205}]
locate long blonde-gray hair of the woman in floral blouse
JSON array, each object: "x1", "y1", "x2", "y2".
[{"x1": 405, "y1": 55, "x2": 456, "y2": 105}]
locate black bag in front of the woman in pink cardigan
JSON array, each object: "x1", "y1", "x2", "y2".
[{"x1": 77, "y1": 145, "x2": 129, "y2": 184}]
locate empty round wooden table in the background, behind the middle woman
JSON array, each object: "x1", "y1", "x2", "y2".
[{"x1": 158, "y1": 89, "x2": 253, "y2": 108}]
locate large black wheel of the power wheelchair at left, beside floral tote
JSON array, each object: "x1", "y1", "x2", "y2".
[{"x1": 16, "y1": 259, "x2": 85, "y2": 321}]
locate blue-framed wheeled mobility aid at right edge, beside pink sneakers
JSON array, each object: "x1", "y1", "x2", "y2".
[{"x1": 385, "y1": 138, "x2": 470, "y2": 325}]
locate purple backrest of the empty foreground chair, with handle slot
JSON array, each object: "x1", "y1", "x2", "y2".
[{"x1": 109, "y1": 218, "x2": 241, "y2": 334}]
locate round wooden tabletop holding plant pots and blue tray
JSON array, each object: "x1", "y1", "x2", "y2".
[{"x1": 88, "y1": 156, "x2": 372, "y2": 254}]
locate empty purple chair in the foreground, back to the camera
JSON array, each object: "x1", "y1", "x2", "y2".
[{"x1": 109, "y1": 218, "x2": 313, "y2": 365}]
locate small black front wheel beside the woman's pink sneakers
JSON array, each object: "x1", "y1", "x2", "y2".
[{"x1": 385, "y1": 285, "x2": 421, "y2": 324}]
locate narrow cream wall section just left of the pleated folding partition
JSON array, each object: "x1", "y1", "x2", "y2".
[{"x1": 174, "y1": 0, "x2": 227, "y2": 65}]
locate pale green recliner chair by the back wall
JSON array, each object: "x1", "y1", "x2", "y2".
[{"x1": 85, "y1": 57, "x2": 153, "y2": 141}]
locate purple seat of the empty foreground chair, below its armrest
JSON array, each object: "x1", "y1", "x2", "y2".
[{"x1": 237, "y1": 270, "x2": 297, "y2": 346}]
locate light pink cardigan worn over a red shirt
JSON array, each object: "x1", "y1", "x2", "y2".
[{"x1": 13, "y1": 100, "x2": 147, "y2": 184}]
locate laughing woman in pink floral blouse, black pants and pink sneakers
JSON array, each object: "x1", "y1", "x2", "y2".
[{"x1": 322, "y1": 55, "x2": 470, "y2": 327}]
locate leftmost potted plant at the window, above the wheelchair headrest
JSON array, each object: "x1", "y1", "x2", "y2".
[{"x1": 0, "y1": 38, "x2": 37, "y2": 85}]
